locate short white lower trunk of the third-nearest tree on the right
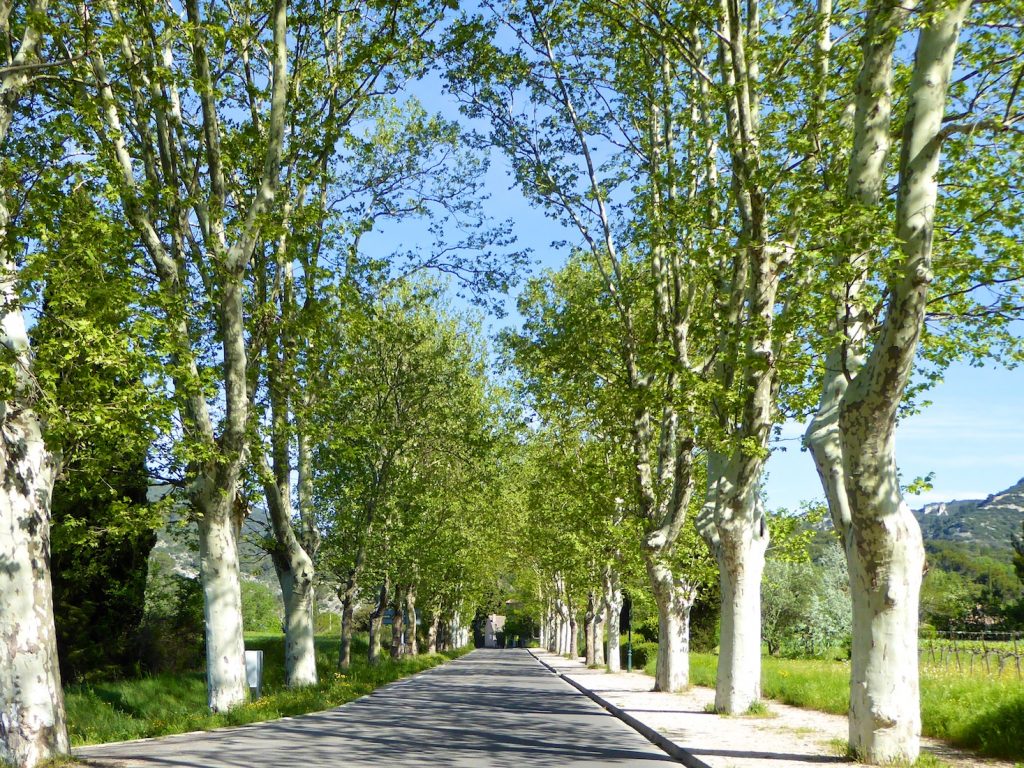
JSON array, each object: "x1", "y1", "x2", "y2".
[{"x1": 645, "y1": 558, "x2": 696, "y2": 693}]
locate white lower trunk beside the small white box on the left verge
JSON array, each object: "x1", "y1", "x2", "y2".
[{"x1": 199, "y1": 493, "x2": 249, "y2": 712}]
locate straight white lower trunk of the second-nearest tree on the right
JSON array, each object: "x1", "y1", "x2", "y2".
[{"x1": 715, "y1": 526, "x2": 768, "y2": 715}]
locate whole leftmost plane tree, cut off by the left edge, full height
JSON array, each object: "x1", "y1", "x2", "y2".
[{"x1": 0, "y1": 2, "x2": 69, "y2": 768}]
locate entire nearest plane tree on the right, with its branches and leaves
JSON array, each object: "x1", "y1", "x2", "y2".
[{"x1": 806, "y1": 2, "x2": 1021, "y2": 762}]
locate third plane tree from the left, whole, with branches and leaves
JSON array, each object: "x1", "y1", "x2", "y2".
[{"x1": 251, "y1": 2, "x2": 471, "y2": 685}]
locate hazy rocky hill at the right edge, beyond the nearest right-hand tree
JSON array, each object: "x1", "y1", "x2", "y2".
[{"x1": 913, "y1": 477, "x2": 1024, "y2": 550}]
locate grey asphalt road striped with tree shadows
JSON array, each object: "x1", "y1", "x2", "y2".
[{"x1": 75, "y1": 649, "x2": 678, "y2": 768}]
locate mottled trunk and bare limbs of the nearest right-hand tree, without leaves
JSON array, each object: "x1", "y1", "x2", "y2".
[{"x1": 807, "y1": 0, "x2": 970, "y2": 763}]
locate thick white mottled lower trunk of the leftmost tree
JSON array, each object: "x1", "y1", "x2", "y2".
[{"x1": 0, "y1": 370, "x2": 69, "y2": 767}]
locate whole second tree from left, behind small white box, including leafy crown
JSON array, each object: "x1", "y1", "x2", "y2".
[{"x1": 79, "y1": 0, "x2": 289, "y2": 712}]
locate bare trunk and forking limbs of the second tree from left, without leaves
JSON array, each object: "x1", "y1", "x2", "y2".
[{"x1": 88, "y1": 0, "x2": 289, "y2": 712}]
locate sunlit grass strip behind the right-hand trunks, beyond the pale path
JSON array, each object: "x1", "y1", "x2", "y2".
[{"x1": 644, "y1": 653, "x2": 1024, "y2": 761}]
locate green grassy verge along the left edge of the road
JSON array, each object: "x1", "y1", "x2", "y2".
[{"x1": 65, "y1": 635, "x2": 469, "y2": 746}]
